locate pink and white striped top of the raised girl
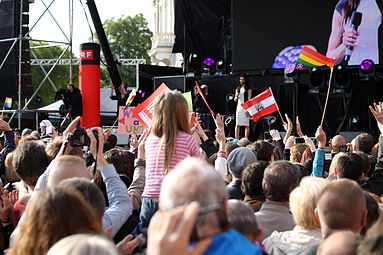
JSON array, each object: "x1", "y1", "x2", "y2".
[{"x1": 142, "y1": 132, "x2": 204, "y2": 197}]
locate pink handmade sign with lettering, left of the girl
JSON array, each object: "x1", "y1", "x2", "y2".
[{"x1": 118, "y1": 106, "x2": 145, "y2": 135}]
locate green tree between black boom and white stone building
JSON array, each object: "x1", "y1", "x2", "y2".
[{"x1": 96, "y1": 14, "x2": 153, "y2": 87}]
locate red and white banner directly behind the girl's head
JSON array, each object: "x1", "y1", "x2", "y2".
[{"x1": 132, "y1": 83, "x2": 170, "y2": 129}]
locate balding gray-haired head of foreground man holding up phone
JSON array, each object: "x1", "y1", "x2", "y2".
[{"x1": 160, "y1": 157, "x2": 227, "y2": 212}]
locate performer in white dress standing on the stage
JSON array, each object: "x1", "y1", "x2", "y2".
[{"x1": 234, "y1": 75, "x2": 251, "y2": 139}]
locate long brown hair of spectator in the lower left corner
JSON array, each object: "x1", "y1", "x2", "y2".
[{"x1": 8, "y1": 188, "x2": 102, "y2": 255}]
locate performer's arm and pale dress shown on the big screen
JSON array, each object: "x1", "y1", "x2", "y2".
[{"x1": 326, "y1": 0, "x2": 382, "y2": 65}]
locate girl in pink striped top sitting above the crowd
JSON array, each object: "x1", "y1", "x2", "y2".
[{"x1": 140, "y1": 91, "x2": 204, "y2": 226}]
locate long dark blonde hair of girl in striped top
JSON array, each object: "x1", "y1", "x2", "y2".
[{"x1": 152, "y1": 90, "x2": 190, "y2": 168}]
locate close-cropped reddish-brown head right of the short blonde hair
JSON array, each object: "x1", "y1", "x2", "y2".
[{"x1": 316, "y1": 179, "x2": 367, "y2": 238}]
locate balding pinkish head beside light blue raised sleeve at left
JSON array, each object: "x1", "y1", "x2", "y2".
[{"x1": 48, "y1": 155, "x2": 90, "y2": 187}]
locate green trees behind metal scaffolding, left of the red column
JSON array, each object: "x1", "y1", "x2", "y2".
[{"x1": 28, "y1": 43, "x2": 78, "y2": 109}]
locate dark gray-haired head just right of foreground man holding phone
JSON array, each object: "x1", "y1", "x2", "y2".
[{"x1": 227, "y1": 199, "x2": 259, "y2": 237}]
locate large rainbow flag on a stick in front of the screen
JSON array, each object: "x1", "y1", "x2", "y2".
[{"x1": 297, "y1": 46, "x2": 334, "y2": 70}]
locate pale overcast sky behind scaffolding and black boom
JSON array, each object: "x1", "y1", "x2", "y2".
[{"x1": 29, "y1": 0, "x2": 154, "y2": 55}]
